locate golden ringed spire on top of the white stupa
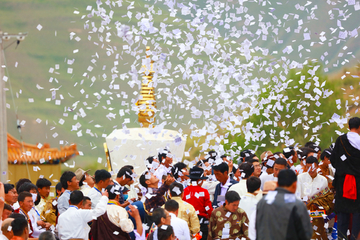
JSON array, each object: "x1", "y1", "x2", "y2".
[{"x1": 137, "y1": 47, "x2": 156, "y2": 128}]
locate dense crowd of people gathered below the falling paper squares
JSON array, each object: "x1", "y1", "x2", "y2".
[{"x1": 0, "y1": 117, "x2": 360, "y2": 240}]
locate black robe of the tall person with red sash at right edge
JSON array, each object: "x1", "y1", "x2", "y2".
[{"x1": 330, "y1": 134, "x2": 360, "y2": 213}]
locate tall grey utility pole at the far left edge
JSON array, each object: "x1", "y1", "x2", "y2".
[{"x1": 0, "y1": 30, "x2": 8, "y2": 183}]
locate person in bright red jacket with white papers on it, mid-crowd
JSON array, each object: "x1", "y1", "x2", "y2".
[{"x1": 183, "y1": 167, "x2": 213, "y2": 239}]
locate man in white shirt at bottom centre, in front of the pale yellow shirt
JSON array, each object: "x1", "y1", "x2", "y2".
[{"x1": 165, "y1": 199, "x2": 191, "y2": 240}]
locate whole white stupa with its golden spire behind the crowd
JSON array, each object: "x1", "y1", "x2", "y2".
[{"x1": 105, "y1": 47, "x2": 186, "y2": 175}]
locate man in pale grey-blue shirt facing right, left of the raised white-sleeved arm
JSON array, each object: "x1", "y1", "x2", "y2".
[{"x1": 57, "y1": 171, "x2": 79, "y2": 214}]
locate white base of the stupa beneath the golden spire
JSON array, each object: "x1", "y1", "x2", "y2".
[{"x1": 106, "y1": 128, "x2": 186, "y2": 175}]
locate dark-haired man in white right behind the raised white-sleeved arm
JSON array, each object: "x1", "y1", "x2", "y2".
[{"x1": 88, "y1": 169, "x2": 111, "y2": 209}]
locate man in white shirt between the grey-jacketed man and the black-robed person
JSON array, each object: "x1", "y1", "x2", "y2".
[{"x1": 295, "y1": 156, "x2": 328, "y2": 201}]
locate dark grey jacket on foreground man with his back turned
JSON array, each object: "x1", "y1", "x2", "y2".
[{"x1": 255, "y1": 187, "x2": 313, "y2": 240}]
